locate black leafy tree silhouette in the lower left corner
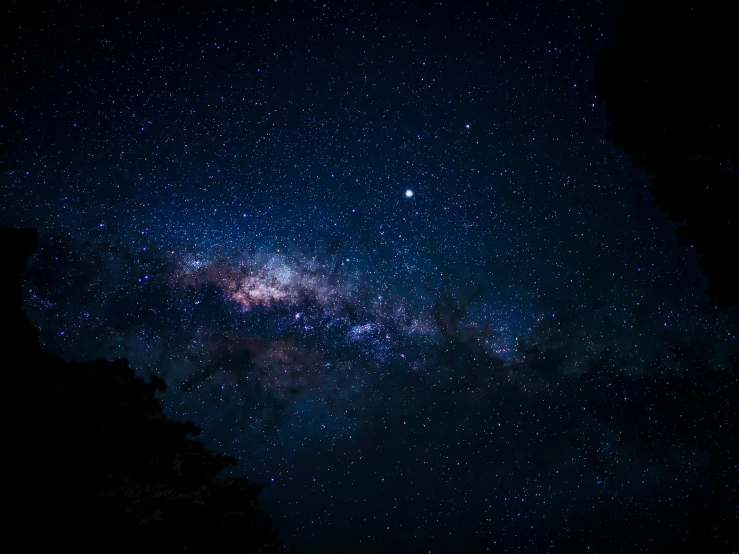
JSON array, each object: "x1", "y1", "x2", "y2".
[{"x1": 0, "y1": 229, "x2": 278, "y2": 553}]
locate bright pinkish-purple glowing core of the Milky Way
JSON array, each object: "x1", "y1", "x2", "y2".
[{"x1": 171, "y1": 246, "x2": 532, "y2": 401}]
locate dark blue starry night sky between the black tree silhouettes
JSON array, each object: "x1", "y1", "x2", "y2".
[{"x1": 0, "y1": 0, "x2": 737, "y2": 552}]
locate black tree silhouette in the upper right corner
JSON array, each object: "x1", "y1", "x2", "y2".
[{"x1": 592, "y1": 0, "x2": 739, "y2": 305}]
